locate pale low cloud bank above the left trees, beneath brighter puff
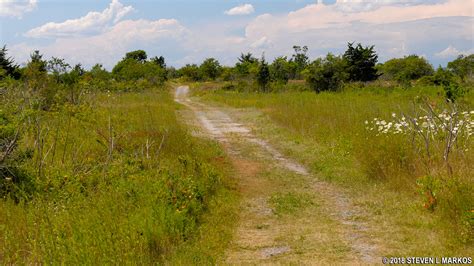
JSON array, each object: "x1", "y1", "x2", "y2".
[{"x1": 9, "y1": 19, "x2": 187, "y2": 69}]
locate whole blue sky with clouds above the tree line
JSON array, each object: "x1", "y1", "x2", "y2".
[{"x1": 0, "y1": 0, "x2": 474, "y2": 69}]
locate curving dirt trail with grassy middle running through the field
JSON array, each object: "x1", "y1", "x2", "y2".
[{"x1": 175, "y1": 86, "x2": 380, "y2": 264}]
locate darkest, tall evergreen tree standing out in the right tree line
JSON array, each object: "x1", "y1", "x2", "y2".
[{"x1": 343, "y1": 43, "x2": 379, "y2": 81}]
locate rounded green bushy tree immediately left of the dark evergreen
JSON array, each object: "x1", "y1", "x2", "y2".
[{"x1": 303, "y1": 53, "x2": 349, "y2": 93}]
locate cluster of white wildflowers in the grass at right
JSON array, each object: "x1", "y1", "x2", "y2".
[{"x1": 365, "y1": 110, "x2": 474, "y2": 138}]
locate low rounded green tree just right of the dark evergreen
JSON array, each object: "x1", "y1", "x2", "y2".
[{"x1": 380, "y1": 55, "x2": 434, "y2": 83}]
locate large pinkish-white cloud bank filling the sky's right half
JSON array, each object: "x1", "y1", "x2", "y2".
[{"x1": 241, "y1": 0, "x2": 473, "y2": 61}]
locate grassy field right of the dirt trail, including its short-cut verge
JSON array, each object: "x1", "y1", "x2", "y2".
[{"x1": 194, "y1": 83, "x2": 474, "y2": 256}]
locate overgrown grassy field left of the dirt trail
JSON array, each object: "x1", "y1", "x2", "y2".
[{"x1": 0, "y1": 83, "x2": 238, "y2": 264}]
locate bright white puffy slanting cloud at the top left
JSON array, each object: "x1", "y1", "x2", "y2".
[{"x1": 25, "y1": 0, "x2": 133, "y2": 38}]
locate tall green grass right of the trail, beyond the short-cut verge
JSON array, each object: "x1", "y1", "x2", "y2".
[{"x1": 199, "y1": 83, "x2": 474, "y2": 245}]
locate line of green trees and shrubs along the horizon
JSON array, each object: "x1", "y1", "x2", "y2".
[{"x1": 0, "y1": 43, "x2": 474, "y2": 100}]
